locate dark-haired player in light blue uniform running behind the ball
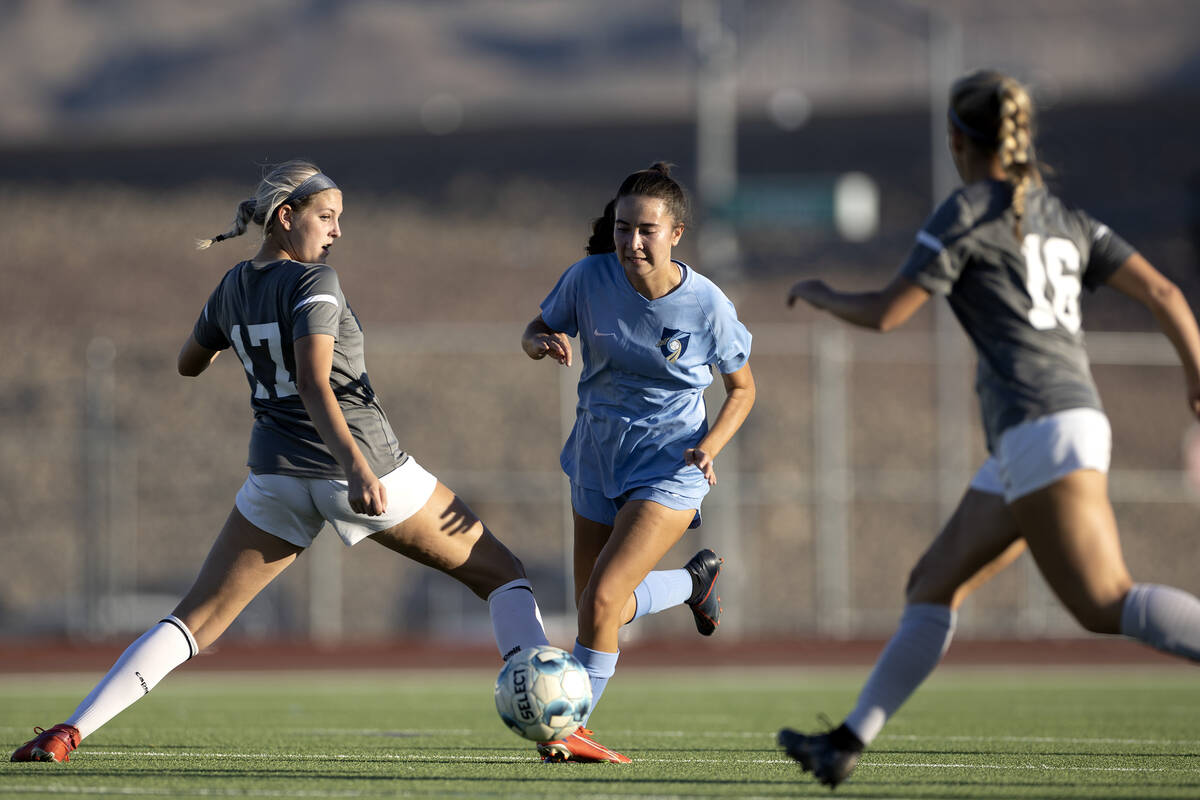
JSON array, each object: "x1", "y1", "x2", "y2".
[{"x1": 521, "y1": 163, "x2": 755, "y2": 762}]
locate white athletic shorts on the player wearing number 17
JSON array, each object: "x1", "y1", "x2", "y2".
[{"x1": 235, "y1": 456, "x2": 438, "y2": 547}]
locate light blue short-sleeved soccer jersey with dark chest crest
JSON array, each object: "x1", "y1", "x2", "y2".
[{"x1": 541, "y1": 253, "x2": 750, "y2": 498}]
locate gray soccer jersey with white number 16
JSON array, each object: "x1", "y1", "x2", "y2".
[{"x1": 900, "y1": 181, "x2": 1134, "y2": 449}]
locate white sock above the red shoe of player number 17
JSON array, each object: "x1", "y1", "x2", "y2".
[{"x1": 66, "y1": 616, "x2": 198, "y2": 739}]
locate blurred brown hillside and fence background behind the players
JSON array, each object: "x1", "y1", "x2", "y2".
[{"x1": 0, "y1": 0, "x2": 1200, "y2": 642}]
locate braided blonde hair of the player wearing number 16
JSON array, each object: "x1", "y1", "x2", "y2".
[{"x1": 950, "y1": 70, "x2": 1042, "y2": 229}]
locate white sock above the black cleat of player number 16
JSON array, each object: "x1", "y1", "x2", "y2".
[{"x1": 846, "y1": 603, "x2": 956, "y2": 745}]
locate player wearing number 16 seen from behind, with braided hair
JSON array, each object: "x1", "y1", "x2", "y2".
[{"x1": 779, "y1": 72, "x2": 1200, "y2": 787}]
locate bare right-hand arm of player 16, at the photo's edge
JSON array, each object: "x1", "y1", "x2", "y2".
[{"x1": 1109, "y1": 253, "x2": 1200, "y2": 417}]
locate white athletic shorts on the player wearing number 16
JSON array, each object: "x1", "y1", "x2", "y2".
[{"x1": 971, "y1": 408, "x2": 1112, "y2": 503}]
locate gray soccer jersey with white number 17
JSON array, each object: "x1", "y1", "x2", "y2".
[{"x1": 193, "y1": 260, "x2": 407, "y2": 480}]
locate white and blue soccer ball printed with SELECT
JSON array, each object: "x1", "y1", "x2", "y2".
[{"x1": 496, "y1": 645, "x2": 592, "y2": 741}]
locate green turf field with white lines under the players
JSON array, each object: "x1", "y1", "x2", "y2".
[{"x1": 0, "y1": 668, "x2": 1200, "y2": 800}]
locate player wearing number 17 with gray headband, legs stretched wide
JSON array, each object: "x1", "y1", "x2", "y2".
[{"x1": 12, "y1": 161, "x2": 546, "y2": 762}]
